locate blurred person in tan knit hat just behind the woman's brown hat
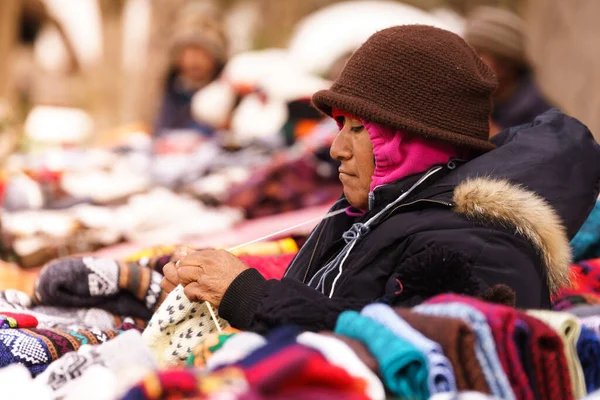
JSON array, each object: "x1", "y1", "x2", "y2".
[{"x1": 465, "y1": 6, "x2": 552, "y2": 129}]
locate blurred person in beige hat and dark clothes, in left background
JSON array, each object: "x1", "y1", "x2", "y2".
[{"x1": 154, "y1": 2, "x2": 228, "y2": 136}]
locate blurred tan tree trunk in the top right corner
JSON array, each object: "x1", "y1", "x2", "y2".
[{"x1": 525, "y1": 0, "x2": 600, "y2": 141}]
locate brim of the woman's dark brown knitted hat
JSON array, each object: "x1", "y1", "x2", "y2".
[{"x1": 312, "y1": 90, "x2": 496, "y2": 154}]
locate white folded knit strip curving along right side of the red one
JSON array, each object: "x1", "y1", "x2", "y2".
[{"x1": 297, "y1": 332, "x2": 385, "y2": 399}]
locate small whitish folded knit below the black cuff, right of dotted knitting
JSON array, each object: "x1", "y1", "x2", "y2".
[{"x1": 206, "y1": 332, "x2": 267, "y2": 371}]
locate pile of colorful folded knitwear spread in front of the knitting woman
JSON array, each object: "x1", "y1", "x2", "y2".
[{"x1": 0, "y1": 240, "x2": 600, "y2": 400}]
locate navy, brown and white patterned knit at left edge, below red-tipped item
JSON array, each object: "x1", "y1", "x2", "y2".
[{"x1": 0, "y1": 324, "x2": 136, "y2": 376}]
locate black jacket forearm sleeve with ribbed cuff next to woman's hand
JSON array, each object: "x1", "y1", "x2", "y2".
[{"x1": 219, "y1": 268, "x2": 369, "y2": 333}]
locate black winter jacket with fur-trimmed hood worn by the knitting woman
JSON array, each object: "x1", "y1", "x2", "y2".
[{"x1": 219, "y1": 110, "x2": 600, "y2": 332}]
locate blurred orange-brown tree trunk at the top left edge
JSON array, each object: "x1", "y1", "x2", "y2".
[{"x1": 0, "y1": 0, "x2": 21, "y2": 103}]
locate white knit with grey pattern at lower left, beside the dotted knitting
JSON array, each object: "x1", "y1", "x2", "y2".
[{"x1": 36, "y1": 331, "x2": 156, "y2": 397}]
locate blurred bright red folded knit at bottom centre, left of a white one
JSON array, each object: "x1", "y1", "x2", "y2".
[{"x1": 246, "y1": 345, "x2": 368, "y2": 399}]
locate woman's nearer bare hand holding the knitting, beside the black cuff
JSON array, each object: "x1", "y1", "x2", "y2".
[{"x1": 177, "y1": 250, "x2": 248, "y2": 307}]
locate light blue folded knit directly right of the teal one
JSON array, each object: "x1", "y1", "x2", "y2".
[{"x1": 360, "y1": 304, "x2": 456, "y2": 394}]
